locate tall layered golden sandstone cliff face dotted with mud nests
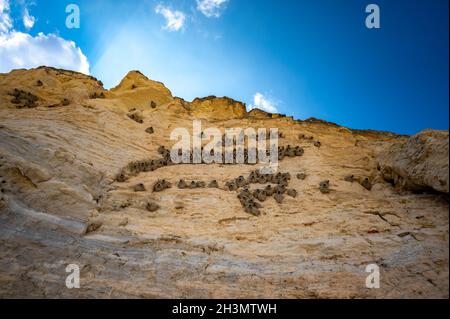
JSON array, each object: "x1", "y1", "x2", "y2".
[{"x1": 0, "y1": 68, "x2": 449, "y2": 298}]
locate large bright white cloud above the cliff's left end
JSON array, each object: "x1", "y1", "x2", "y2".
[{"x1": 0, "y1": 32, "x2": 89, "y2": 74}]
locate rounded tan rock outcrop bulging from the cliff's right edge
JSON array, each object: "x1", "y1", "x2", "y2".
[{"x1": 379, "y1": 130, "x2": 449, "y2": 193}]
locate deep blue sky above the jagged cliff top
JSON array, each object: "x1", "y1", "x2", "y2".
[{"x1": 0, "y1": 0, "x2": 449, "y2": 134}]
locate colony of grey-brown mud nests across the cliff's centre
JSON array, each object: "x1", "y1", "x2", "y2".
[{"x1": 110, "y1": 122, "x2": 372, "y2": 216}]
